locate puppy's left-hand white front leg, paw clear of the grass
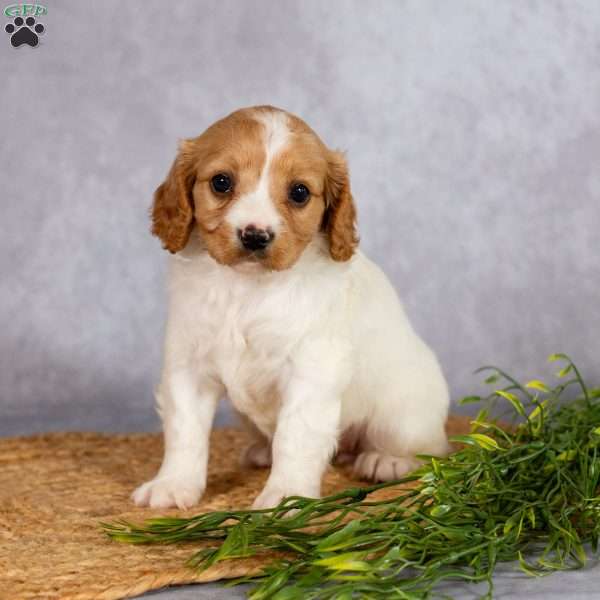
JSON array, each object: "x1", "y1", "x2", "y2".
[{"x1": 132, "y1": 370, "x2": 222, "y2": 509}]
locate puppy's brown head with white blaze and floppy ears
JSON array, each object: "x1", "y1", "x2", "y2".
[{"x1": 152, "y1": 106, "x2": 357, "y2": 270}]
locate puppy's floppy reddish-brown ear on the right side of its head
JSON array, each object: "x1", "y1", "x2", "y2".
[{"x1": 323, "y1": 152, "x2": 358, "y2": 261}]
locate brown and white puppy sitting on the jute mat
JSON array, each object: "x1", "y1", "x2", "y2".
[{"x1": 133, "y1": 106, "x2": 448, "y2": 508}]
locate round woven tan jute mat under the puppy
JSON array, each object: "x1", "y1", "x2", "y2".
[{"x1": 0, "y1": 417, "x2": 468, "y2": 600}]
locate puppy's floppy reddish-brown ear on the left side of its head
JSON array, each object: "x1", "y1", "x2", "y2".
[{"x1": 152, "y1": 142, "x2": 194, "y2": 253}]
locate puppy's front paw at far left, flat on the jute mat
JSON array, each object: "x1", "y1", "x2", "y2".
[{"x1": 131, "y1": 476, "x2": 204, "y2": 509}]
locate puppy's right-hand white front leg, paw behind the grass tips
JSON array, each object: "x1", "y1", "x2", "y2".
[{"x1": 253, "y1": 344, "x2": 342, "y2": 508}]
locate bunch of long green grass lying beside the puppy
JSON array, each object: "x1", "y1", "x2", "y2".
[{"x1": 104, "y1": 354, "x2": 600, "y2": 599}]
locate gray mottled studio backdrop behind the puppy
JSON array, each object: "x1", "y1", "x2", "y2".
[{"x1": 0, "y1": 0, "x2": 600, "y2": 433}]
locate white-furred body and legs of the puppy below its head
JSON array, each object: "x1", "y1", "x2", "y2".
[{"x1": 134, "y1": 232, "x2": 448, "y2": 507}]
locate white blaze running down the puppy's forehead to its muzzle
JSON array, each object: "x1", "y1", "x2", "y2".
[{"x1": 226, "y1": 111, "x2": 290, "y2": 233}]
